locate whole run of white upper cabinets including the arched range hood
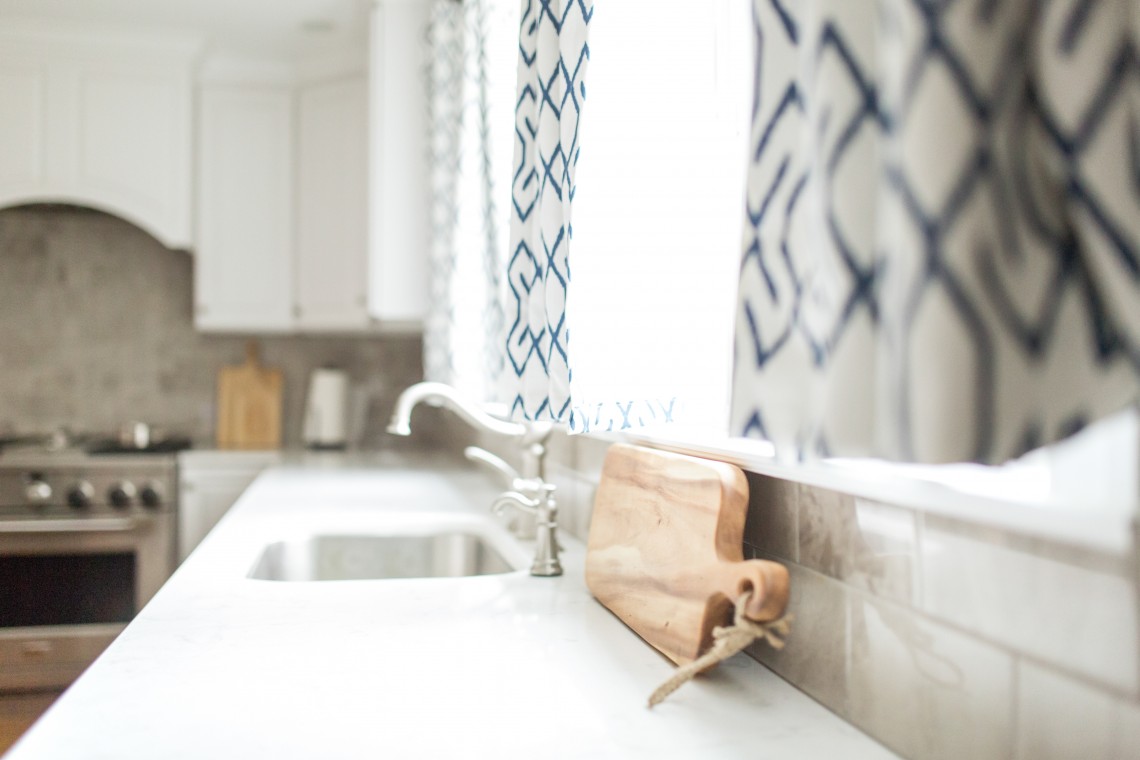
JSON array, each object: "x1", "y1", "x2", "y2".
[{"x1": 0, "y1": 5, "x2": 430, "y2": 333}]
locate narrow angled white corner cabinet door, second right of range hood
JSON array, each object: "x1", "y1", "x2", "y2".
[{"x1": 294, "y1": 77, "x2": 369, "y2": 330}]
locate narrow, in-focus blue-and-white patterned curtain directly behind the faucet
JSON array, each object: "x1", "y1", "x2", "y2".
[{"x1": 500, "y1": 0, "x2": 594, "y2": 420}]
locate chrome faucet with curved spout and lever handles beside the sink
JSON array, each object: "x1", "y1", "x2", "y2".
[{"x1": 388, "y1": 383, "x2": 562, "y2": 577}]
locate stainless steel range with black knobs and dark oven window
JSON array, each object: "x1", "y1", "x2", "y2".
[{"x1": 0, "y1": 442, "x2": 178, "y2": 693}]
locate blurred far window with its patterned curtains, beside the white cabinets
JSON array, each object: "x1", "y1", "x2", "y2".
[{"x1": 424, "y1": 0, "x2": 518, "y2": 399}]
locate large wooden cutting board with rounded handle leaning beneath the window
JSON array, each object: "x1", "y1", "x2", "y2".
[{"x1": 586, "y1": 443, "x2": 788, "y2": 664}]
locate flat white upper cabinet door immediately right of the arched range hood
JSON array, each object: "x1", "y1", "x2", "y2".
[{"x1": 195, "y1": 87, "x2": 293, "y2": 332}]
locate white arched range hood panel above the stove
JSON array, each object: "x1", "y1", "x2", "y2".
[{"x1": 0, "y1": 24, "x2": 197, "y2": 248}]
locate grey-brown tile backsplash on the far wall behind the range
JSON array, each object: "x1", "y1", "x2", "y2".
[{"x1": 0, "y1": 205, "x2": 447, "y2": 447}]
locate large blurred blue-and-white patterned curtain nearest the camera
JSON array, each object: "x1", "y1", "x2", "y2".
[{"x1": 732, "y1": 0, "x2": 1140, "y2": 463}]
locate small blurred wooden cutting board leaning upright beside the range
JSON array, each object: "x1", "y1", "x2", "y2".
[{"x1": 217, "y1": 341, "x2": 284, "y2": 449}]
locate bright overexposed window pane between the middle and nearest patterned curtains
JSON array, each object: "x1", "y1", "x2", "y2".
[{"x1": 567, "y1": 0, "x2": 751, "y2": 434}]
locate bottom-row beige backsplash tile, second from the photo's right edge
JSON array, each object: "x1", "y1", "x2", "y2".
[{"x1": 845, "y1": 591, "x2": 1013, "y2": 760}]
